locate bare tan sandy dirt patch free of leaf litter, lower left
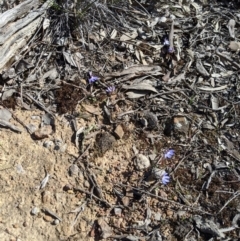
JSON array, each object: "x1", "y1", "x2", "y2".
[{"x1": 0, "y1": 110, "x2": 135, "y2": 241}]
